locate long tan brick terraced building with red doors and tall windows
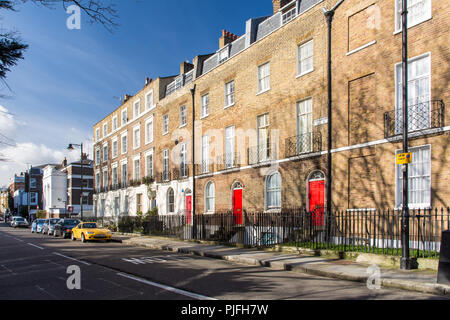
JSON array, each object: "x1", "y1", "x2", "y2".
[{"x1": 94, "y1": 0, "x2": 450, "y2": 220}]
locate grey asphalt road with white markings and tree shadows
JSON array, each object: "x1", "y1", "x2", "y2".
[{"x1": 0, "y1": 225, "x2": 443, "y2": 301}]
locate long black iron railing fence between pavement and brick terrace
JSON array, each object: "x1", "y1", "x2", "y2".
[{"x1": 115, "y1": 208, "x2": 450, "y2": 259}]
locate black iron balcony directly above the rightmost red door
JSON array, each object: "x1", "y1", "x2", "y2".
[{"x1": 285, "y1": 132, "x2": 322, "y2": 158}]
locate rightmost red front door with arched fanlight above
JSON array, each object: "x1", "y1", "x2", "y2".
[{"x1": 308, "y1": 170, "x2": 325, "y2": 226}]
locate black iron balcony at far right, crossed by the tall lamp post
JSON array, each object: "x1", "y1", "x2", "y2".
[{"x1": 384, "y1": 100, "x2": 445, "y2": 138}]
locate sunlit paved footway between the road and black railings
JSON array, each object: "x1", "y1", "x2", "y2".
[{"x1": 115, "y1": 234, "x2": 450, "y2": 296}]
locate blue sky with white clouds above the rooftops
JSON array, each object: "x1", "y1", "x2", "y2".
[{"x1": 0, "y1": 0, "x2": 272, "y2": 186}]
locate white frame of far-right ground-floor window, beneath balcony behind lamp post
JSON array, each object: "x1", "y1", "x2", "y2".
[{"x1": 395, "y1": 144, "x2": 433, "y2": 209}]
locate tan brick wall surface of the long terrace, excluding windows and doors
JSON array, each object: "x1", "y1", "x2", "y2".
[{"x1": 94, "y1": 0, "x2": 450, "y2": 218}]
